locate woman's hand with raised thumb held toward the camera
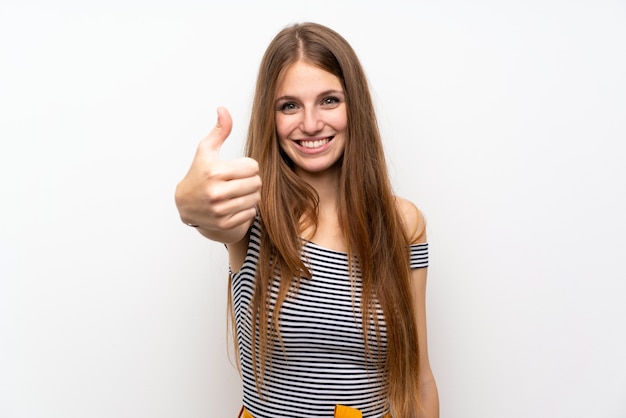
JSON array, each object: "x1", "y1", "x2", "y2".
[{"x1": 175, "y1": 107, "x2": 261, "y2": 244}]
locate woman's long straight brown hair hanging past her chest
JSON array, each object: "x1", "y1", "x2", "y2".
[{"x1": 236, "y1": 23, "x2": 421, "y2": 418}]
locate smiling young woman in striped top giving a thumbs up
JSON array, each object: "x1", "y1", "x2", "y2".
[{"x1": 176, "y1": 23, "x2": 439, "y2": 418}]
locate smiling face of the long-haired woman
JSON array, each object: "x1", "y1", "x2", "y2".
[{"x1": 275, "y1": 61, "x2": 348, "y2": 176}]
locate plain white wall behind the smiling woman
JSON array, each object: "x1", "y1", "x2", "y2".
[{"x1": 0, "y1": 0, "x2": 626, "y2": 418}]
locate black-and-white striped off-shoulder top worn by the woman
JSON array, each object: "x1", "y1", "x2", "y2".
[{"x1": 232, "y1": 219, "x2": 428, "y2": 418}]
